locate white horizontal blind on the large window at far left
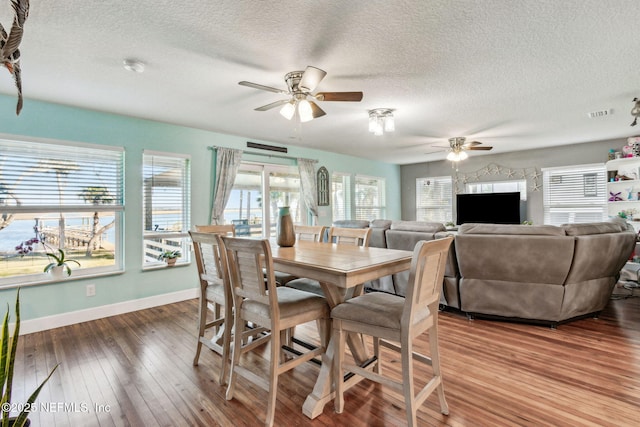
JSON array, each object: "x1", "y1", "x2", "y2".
[{"x1": 0, "y1": 139, "x2": 124, "y2": 213}]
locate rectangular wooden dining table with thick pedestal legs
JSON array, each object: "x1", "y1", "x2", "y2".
[{"x1": 271, "y1": 241, "x2": 412, "y2": 419}]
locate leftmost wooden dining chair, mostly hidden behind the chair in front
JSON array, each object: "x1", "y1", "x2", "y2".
[{"x1": 189, "y1": 224, "x2": 235, "y2": 384}]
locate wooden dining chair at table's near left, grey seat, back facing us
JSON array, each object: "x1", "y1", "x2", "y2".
[{"x1": 221, "y1": 237, "x2": 331, "y2": 426}]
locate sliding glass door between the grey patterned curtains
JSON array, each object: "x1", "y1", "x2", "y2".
[{"x1": 224, "y1": 163, "x2": 306, "y2": 237}]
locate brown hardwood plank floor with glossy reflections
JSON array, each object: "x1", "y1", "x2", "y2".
[{"x1": 12, "y1": 289, "x2": 640, "y2": 427}]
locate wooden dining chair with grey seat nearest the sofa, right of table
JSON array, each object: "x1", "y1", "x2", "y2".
[{"x1": 331, "y1": 236, "x2": 453, "y2": 426}]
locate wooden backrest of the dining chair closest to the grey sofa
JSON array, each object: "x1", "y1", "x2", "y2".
[{"x1": 403, "y1": 236, "x2": 453, "y2": 323}]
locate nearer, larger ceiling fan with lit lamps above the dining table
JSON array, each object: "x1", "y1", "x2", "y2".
[{"x1": 238, "y1": 66, "x2": 362, "y2": 122}]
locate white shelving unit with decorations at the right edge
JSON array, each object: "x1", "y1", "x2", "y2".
[{"x1": 607, "y1": 157, "x2": 640, "y2": 231}]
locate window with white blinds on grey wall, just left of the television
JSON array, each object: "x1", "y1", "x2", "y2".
[{"x1": 416, "y1": 176, "x2": 453, "y2": 224}]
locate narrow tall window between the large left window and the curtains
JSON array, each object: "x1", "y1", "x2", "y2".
[{"x1": 142, "y1": 151, "x2": 191, "y2": 267}]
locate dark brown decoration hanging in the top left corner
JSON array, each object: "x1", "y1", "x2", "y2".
[{"x1": 0, "y1": 0, "x2": 29, "y2": 115}]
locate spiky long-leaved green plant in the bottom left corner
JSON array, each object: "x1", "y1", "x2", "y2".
[{"x1": 0, "y1": 289, "x2": 58, "y2": 427}]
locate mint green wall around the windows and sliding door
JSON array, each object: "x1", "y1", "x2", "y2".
[{"x1": 0, "y1": 95, "x2": 400, "y2": 320}]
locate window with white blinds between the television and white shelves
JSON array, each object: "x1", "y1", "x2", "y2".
[{"x1": 542, "y1": 164, "x2": 607, "y2": 225}]
